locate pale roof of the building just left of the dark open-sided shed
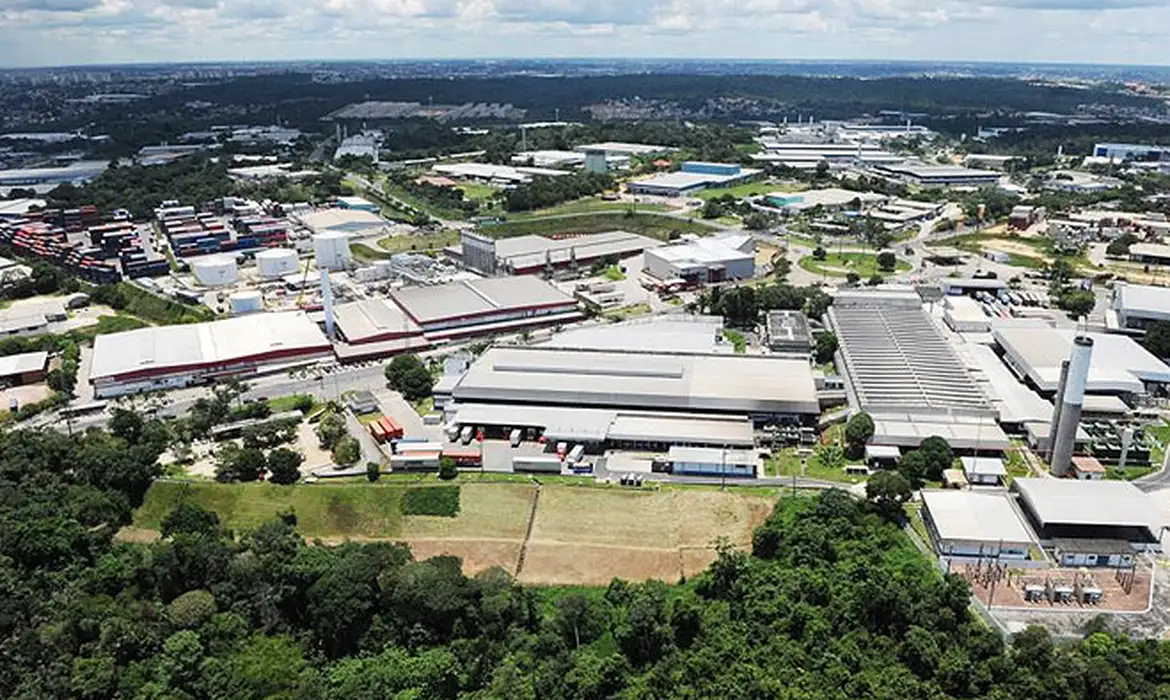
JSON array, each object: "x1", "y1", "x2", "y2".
[{"x1": 922, "y1": 490, "x2": 1033, "y2": 544}]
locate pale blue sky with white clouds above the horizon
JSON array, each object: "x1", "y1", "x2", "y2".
[{"x1": 0, "y1": 0, "x2": 1170, "y2": 67}]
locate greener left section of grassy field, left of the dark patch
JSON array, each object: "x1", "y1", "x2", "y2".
[{"x1": 133, "y1": 481, "x2": 402, "y2": 538}]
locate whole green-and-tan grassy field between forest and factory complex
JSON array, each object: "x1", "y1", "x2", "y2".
[{"x1": 130, "y1": 482, "x2": 776, "y2": 585}]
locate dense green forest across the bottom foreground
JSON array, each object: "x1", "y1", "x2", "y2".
[{"x1": 0, "y1": 414, "x2": 1170, "y2": 700}]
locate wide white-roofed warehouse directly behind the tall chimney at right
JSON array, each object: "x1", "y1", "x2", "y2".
[{"x1": 992, "y1": 327, "x2": 1170, "y2": 394}]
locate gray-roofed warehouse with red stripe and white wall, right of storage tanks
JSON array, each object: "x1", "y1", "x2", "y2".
[{"x1": 391, "y1": 276, "x2": 581, "y2": 341}]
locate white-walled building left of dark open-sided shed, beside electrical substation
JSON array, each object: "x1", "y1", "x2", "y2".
[{"x1": 922, "y1": 490, "x2": 1033, "y2": 560}]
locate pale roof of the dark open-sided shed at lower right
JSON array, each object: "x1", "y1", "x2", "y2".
[{"x1": 1012, "y1": 479, "x2": 1162, "y2": 533}]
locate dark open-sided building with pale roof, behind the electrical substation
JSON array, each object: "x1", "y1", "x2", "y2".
[{"x1": 1012, "y1": 479, "x2": 1164, "y2": 550}]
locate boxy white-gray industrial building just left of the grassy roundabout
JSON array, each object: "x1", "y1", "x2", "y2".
[{"x1": 642, "y1": 234, "x2": 756, "y2": 284}]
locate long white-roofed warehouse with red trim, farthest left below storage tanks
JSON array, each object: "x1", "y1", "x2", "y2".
[{"x1": 89, "y1": 311, "x2": 332, "y2": 398}]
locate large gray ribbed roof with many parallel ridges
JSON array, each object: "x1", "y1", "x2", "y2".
[{"x1": 828, "y1": 295, "x2": 992, "y2": 416}]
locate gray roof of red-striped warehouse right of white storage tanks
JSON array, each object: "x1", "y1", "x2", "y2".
[{"x1": 391, "y1": 275, "x2": 573, "y2": 323}]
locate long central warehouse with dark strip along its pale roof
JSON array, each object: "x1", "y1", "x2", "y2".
[{"x1": 452, "y1": 346, "x2": 820, "y2": 424}]
